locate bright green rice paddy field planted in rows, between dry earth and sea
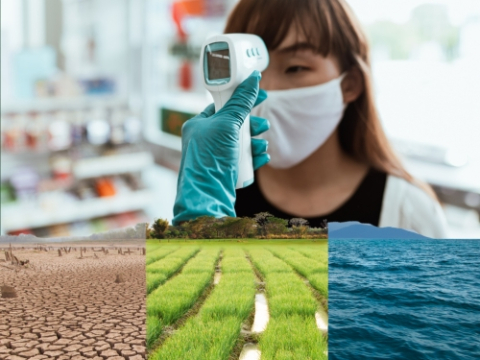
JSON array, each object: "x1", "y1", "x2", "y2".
[{"x1": 147, "y1": 241, "x2": 328, "y2": 360}]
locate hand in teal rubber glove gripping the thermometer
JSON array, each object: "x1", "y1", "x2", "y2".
[{"x1": 173, "y1": 71, "x2": 270, "y2": 225}]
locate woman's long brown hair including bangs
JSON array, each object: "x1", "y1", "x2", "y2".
[{"x1": 225, "y1": 0, "x2": 436, "y2": 198}]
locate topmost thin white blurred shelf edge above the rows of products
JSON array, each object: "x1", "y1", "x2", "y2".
[{"x1": 1, "y1": 95, "x2": 127, "y2": 113}]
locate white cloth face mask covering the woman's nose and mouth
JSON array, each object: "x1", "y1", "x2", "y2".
[{"x1": 252, "y1": 73, "x2": 346, "y2": 169}]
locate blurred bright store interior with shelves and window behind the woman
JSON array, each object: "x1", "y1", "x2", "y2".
[{"x1": 1, "y1": 0, "x2": 480, "y2": 238}]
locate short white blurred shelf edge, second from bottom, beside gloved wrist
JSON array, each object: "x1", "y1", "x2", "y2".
[{"x1": 73, "y1": 152, "x2": 154, "y2": 179}]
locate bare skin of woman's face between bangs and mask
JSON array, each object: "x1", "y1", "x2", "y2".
[{"x1": 260, "y1": 26, "x2": 341, "y2": 91}]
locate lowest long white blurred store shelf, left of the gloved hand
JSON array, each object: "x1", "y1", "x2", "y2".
[{"x1": 1, "y1": 189, "x2": 152, "y2": 232}]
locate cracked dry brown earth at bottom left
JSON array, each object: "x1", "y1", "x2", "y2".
[{"x1": 0, "y1": 244, "x2": 146, "y2": 360}]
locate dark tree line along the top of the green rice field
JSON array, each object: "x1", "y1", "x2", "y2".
[{"x1": 147, "y1": 212, "x2": 328, "y2": 239}]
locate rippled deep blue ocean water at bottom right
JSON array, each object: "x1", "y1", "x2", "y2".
[{"x1": 328, "y1": 239, "x2": 480, "y2": 360}]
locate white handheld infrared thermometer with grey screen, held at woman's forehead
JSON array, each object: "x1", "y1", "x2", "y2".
[{"x1": 200, "y1": 34, "x2": 269, "y2": 189}]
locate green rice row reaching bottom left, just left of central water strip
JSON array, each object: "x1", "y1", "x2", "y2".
[{"x1": 149, "y1": 250, "x2": 255, "y2": 360}]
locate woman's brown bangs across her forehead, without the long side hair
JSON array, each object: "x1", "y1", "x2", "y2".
[{"x1": 225, "y1": 0, "x2": 342, "y2": 56}]
